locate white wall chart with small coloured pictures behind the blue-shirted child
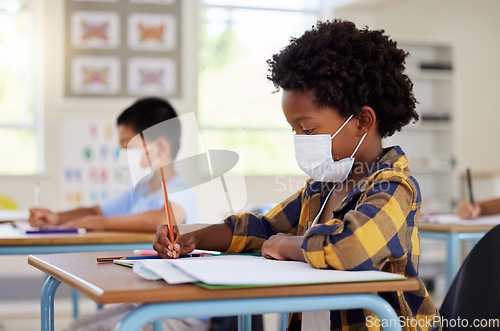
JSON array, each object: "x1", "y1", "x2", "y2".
[{"x1": 61, "y1": 120, "x2": 131, "y2": 209}]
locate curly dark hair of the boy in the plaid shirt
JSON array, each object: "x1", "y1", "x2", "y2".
[{"x1": 267, "y1": 19, "x2": 418, "y2": 137}]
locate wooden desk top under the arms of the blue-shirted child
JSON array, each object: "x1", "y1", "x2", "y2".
[{"x1": 0, "y1": 231, "x2": 154, "y2": 246}]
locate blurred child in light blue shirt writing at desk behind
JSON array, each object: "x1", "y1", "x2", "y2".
[{"x1": 29, "y1": 97, "x2": 197, "y2": 232}]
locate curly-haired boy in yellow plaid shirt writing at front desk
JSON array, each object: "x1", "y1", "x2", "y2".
[{"x1": 154, "y1": 20, "x2": 440, "y2": 330}]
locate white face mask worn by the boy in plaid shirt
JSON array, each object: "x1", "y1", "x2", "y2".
[{"x1": 294, "y1": 115, "x2": 366, "y2": 183}]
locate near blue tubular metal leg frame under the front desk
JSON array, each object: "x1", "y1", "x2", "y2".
[{"x1": 115, "y1": 294, "x2": 401, "y2": 331}]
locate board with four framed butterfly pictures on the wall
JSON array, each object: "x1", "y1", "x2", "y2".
[{"x1": 64, "y1": 0, "x2": 183, "y2": 98}]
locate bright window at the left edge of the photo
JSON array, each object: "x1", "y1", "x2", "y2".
[{"x1": 0, "y1": 0, "x2": 43, "y2": 175}]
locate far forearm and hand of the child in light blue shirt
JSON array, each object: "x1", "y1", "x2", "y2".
[{"x1": 28, "y1": 206, "x2": 102, "y2": 226}]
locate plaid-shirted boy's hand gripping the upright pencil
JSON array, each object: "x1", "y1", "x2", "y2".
[{"x1": 153, "y1": 224, "x2": 196, "y2": 259}]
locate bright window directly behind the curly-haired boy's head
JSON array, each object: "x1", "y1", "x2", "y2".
[{"x1": 198, "y1": 0, "x2": 321, "y2": 175}]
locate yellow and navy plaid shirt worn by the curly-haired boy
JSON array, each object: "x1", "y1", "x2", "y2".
[{"x1": 225, "y1": 146, "x2": 440, "y2": 330}]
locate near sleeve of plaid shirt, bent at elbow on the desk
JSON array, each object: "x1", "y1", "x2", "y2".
[{"x1": 302, "y1": 171, "x2": 419, "y2": 270}]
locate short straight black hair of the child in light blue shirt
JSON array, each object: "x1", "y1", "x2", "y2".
[{"x1": 116, "y1": 97, "x2": 181, "y2": 158}]
